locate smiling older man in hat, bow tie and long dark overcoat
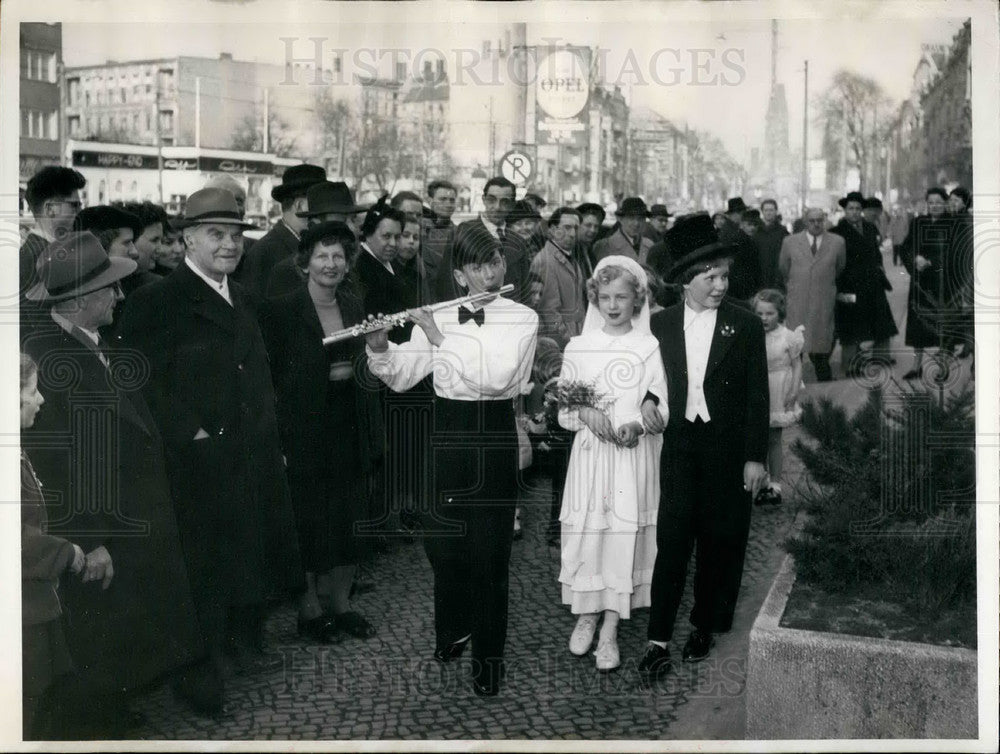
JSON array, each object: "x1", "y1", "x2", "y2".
[{"x1": 120, "y1": 188, "x2": 305, "y2": 713}]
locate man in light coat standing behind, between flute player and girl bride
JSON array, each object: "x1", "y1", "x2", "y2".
[{"x1": 530, "y1": 207, "x2": 587, "y2": 348}]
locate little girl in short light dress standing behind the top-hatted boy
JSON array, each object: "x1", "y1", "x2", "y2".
[{"x1": 751, "y1": 288, "x2": 805, "y2": 505}]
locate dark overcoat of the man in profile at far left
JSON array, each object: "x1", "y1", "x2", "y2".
[{"x1": 22, "y1": 322, "x2": 203, "y2": 693}]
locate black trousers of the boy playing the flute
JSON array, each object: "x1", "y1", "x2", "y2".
[{"x1": 423, "y1": 397, "x2": 518, "y2": 682}]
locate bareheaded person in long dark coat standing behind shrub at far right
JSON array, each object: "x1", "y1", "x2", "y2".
[{"x1": 899, "y1": 187, "x2": 953, "y2": 380}]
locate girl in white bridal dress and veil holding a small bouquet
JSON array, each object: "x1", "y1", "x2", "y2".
[{"x1": 559, "y1": 256, "x2": 667, "y2": 671}]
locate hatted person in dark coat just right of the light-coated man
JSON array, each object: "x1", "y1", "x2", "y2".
[{"x1": 830, "y1": 191, "x2": 899, "y2": 377}]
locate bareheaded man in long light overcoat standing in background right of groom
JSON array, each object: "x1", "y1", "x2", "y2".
[{"x1": 778, "y1": 208, "x2": 847, "y2": 382}]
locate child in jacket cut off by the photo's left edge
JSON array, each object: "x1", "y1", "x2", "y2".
[{"x1": 21, "y1": 353, "x2": 85, "y2": 740}]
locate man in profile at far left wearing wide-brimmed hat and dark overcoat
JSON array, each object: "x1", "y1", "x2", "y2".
[{"x1": 22, "y1": 232, "x2": 204, "y2": 738}]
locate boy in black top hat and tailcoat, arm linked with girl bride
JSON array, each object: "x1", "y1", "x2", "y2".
[{"x1": 639, "y1": 215, "x2": 769, "y2": 676}]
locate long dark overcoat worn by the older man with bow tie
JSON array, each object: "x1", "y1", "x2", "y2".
[{"x1": 120, "y1": 263, "x2": 304, "y2": 609}]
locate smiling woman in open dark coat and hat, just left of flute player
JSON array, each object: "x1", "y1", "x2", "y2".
[{"x1": 262, "y1": 222, "x2": 382, "y2": 641}]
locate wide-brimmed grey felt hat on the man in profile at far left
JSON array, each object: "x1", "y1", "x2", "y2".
[{"x1": 24, "y1": 231, "x2": 138, "y2": 304}]
